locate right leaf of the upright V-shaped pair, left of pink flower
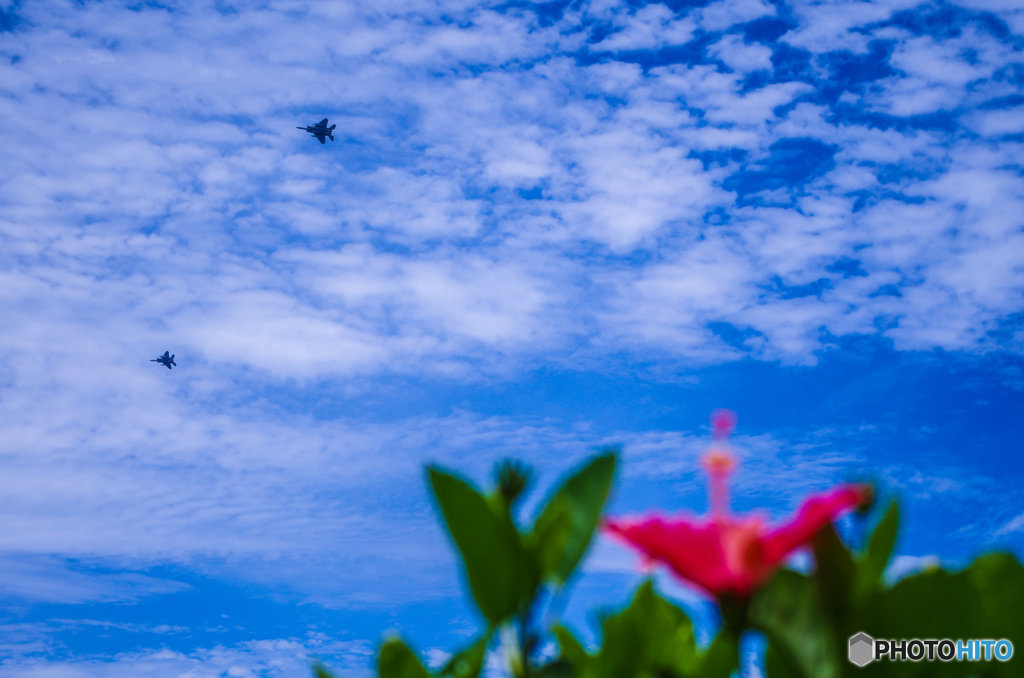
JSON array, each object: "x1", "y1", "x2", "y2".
[{"x1": 534, "y1": 452, "x2": 617, "y2": 584}]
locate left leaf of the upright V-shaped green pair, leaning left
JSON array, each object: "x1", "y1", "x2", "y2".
[{"x1": 428, "y1": 466, "x2": 534, "y2": 627}]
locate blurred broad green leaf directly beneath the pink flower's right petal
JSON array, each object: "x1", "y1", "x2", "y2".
[{"x1": 750, "y1": 569, "x2": 845, "y2": 678}]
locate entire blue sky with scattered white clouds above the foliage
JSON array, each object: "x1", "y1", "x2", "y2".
[{"x1": 0, "y1": 0, "x2": 1024, "y2": 678}]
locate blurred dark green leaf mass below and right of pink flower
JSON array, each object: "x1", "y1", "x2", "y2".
[{"x1": 750, "y1": 501, "x2": 1024, "y2": 678}]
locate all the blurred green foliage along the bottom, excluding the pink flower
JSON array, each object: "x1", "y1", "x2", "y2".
[{"x1": 313, "y1": 451, "x2": 1024, "y2": 678}]
